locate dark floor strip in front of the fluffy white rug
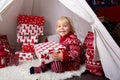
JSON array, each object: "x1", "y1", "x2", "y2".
[{"x1": 65, "y1": 73, "x2": 109, "y2": 80}]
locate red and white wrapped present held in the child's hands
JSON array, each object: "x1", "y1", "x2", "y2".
[{"x1": 34, "y1": 41, "x2": 65, "y2": 64}]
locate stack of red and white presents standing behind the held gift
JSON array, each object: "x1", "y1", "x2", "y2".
[{"x1": 15, "y1": 15, "x2": 44, "y2": 61}]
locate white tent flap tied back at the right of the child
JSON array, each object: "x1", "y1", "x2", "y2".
[{"x1": 59, "y1": 0, "x2": 120, "y2": 80}]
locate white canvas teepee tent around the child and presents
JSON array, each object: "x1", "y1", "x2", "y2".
[{"x1": 0, "y1": 0, "x2": 120, "y2": 80}]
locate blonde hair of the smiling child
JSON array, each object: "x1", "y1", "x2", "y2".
[{"x1": 56, "y1": 16, "x2": 75, "y2": 33}]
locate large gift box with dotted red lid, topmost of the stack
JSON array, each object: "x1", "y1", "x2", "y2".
[{"x1": 17, "y1": 15, "x2": 44, "y2": 43}]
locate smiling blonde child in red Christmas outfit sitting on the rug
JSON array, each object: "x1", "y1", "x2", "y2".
[{"x1": 30, "y1": 16, "x2": 81, "y2": 74}]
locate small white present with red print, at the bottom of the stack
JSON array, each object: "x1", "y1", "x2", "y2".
[{"x1": 15, "y1": 51, "x2": 33, "y2": 61}]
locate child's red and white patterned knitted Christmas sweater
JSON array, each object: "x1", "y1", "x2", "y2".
[{"x1": 60, "y1": 32, "x2": 82, "y2": 71}]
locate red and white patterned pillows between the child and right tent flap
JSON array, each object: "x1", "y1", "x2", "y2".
[{"x1": 83, "y1": 32, "x2": 103, "y2": 76}]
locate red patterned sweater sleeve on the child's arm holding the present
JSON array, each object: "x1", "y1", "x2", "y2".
[{"x1": 62, "y1": 39, "x2": 81, "y2": 61}]
